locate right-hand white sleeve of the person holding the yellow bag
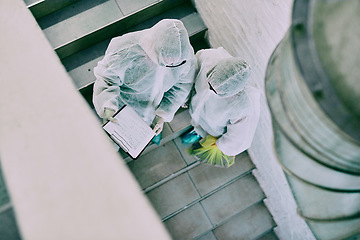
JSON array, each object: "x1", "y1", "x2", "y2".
[{"x1": 216, "y1": 87, "x2": 260, "y2": 156}]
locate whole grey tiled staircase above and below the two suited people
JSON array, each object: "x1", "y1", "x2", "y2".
[{"x1": 0, "y1": 0, "x2": 278, "y2": 240}]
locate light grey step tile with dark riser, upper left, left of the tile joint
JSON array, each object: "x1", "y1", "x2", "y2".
[{"x1": 39, "y1": 0, "x2": 123, "y2": 48}]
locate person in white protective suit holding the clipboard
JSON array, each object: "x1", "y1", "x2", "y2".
[{"x1": 93, "y1": 19, "x2": 196, "y2": 144}]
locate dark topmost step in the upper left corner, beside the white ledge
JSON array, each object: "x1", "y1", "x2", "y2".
[{"x1": 24, "y1": 0, "x2": 78, "y2": 19}]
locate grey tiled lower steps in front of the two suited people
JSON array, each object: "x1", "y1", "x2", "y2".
[{"x1": 124, "y1": 110, "x2": 275, "y2": 240}]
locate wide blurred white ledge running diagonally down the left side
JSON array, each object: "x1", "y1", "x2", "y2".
[{"x1": 0, "y1": 0, "x2": 170, "y2": 240}]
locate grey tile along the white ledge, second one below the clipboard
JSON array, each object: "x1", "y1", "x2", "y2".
[{"x1": 147, "y1": 173, "x2": 200, "y2": 218}]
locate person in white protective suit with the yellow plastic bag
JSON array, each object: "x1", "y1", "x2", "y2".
[{"x1": 182, "y1": 48, "x2": 260, "y2": 167}]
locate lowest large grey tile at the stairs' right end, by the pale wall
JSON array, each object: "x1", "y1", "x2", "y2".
[{"x1": 214, "y1": 202, "x2": 275, "y2": 240}]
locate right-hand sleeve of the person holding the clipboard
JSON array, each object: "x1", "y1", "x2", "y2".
[{"x1": 155, "y1": 57, "x2": 196, "y2": 122}]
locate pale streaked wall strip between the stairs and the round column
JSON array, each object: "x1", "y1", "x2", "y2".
[{"x1": 195, "y1": 0, "x2": 314, "y2": 240}]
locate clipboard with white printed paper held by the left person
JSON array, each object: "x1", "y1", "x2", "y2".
[{"x1": 103, "y1": 105, "x2": 155, "y2": 159}]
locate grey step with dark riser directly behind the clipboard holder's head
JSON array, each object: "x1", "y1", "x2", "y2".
[{"x1": 62, "y1": 3, "x2": 209, "y2": 107}]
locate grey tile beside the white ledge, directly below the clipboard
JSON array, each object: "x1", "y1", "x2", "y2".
[{"x1": 128, "y1": 141, "x2": 186, "y2": 188}]
